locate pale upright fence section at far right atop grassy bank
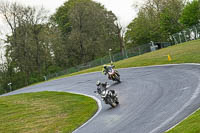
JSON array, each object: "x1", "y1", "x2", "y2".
[{"x1": 170, "y1": 23, "x2": 200, "y2": 44}]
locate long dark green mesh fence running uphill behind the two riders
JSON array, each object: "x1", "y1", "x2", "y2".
[{"x1": 44, "y1": 42, "x2": 171, "y2": 80}]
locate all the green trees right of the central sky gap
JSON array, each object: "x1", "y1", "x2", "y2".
[{"x1": 125, "y1": 0, "x2": 200, "y2": 47}]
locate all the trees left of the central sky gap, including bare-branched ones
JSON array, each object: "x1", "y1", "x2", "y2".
[{"x1": 0, "y1": 0, "x2": 121, "y2": 92}]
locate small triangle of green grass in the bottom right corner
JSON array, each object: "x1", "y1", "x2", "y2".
[{"x1": 166, "y1": 110, "x2": 200, "y2": 133}]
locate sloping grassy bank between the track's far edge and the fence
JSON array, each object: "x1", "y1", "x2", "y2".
[{"x1": 56, "y1": 40, "x2": 200, "y2": 79}]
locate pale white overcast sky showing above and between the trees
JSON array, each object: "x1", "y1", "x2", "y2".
[{"x1": 0, "y1": 0, "x2": 144, "y2": 27}]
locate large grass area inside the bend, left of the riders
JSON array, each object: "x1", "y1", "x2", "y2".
[{"x1": 0, "y1": 92, "x2": 98, "y2": 133}]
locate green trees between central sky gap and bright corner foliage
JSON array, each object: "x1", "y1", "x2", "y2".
[{"x1": 125, "y1": 0, "x2": 184, "y2": 47}]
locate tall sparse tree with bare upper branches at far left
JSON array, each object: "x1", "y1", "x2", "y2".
[{"x1": 0, "y1": 3, "x2": 51, "y2": 88}]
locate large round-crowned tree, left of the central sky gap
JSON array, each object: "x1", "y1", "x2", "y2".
[{"x1": 52, "y1": 0, "x2": 119, "y2": 66}]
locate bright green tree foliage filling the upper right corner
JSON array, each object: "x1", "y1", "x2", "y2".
[{"x1": 180, "y1": 0, "x2": 200, "y2": 27}]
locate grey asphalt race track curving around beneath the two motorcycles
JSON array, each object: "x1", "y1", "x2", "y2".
[{"x1": 1, "y1": 64, "x2": 200, "y2": 133}]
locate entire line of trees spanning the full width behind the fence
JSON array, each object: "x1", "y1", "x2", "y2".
[{"x1": 0, "y1": 0, "x2": 200, "y2": 93}]
